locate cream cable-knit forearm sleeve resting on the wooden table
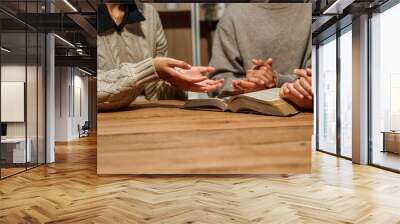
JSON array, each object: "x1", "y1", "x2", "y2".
[{"x1": 97, "y1": 58, "x2": 158, "y2": 111}]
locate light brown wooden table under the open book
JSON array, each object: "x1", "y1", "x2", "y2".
[{"x1": 97, "y1": 101, "x2": 313, "y2": 174}]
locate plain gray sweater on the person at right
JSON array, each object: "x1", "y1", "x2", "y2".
[{"x1": 210, "y1": 3, "x2": 312, "y2": 96}]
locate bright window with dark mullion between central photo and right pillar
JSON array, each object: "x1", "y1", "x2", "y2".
[{"x1": 317, "y1": 24, "x2": 353, "y2": 158}]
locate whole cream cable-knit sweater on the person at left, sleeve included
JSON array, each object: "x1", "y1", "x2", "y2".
[{"x1": 97, "y1": 4, "x2": 185, "y2": 111}]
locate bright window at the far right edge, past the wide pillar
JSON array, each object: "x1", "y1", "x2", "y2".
[{"x1": 370, "y1": 4, "x2": 400, "y2": 170}]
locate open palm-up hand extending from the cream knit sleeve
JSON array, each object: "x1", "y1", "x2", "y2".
[{"x1": 153, "y1": 57, "x2": 223, "y2": 92}]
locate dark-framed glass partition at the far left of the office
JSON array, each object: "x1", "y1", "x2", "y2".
[{"x1": 0, "y1": 0, "x2": 46, "y2": 178}]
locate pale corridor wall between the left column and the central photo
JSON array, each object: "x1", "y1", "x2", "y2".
[{"x1": 55, "y1": 67, "x2": 88, "y2": 141}]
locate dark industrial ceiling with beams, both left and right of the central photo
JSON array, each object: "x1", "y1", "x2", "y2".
[{"x1": 0, "y1": 0, "x2": 387, "y2": 74}]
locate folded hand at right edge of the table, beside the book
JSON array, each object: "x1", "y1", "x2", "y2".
[{"x1": 279, "y1": 69, "x2": 313, "y2": 110}]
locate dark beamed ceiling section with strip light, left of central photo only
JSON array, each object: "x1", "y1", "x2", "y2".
[{"x1": 0, "y1": 0, "x2": 99, "y2": 73}]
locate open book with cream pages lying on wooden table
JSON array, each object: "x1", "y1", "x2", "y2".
[{"x1": 183, "y1": 88, "x2": 299, "y2": 116}]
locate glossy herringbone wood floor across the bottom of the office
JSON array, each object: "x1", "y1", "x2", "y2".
[{"x1": 0, "y1": 137, "x2": 400, "y2": 224}]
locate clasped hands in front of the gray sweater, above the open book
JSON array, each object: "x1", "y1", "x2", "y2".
[{"x1": 232, "y1": 58, "x2": 276, "y2": 95}]
